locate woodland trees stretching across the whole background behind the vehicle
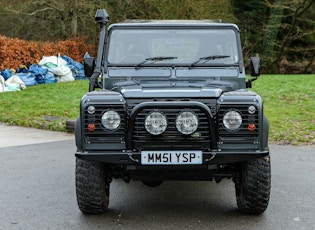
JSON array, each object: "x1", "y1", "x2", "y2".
[{"x1": 0, "y1": 0, "x2": 315, "y2": 73}]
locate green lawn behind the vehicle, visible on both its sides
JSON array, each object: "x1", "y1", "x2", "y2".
[{"x1": 0, "y1": 75, "x2": 315, "y2": 145}]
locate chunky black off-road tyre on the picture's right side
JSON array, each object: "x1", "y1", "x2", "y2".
[{"x1": 234, "y1": 155, "x2": 271, "y2": 215}]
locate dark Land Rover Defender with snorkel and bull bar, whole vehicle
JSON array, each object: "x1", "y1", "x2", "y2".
[{"x1": 75, "y1": 9, "x2": 271, "y2": 214}]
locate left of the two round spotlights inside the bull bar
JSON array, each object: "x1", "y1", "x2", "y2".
[{"x1": 144, "y1": 112, "x2": 167, "y2": 135}]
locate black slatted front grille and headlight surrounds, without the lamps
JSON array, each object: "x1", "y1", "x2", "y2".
[{"x1": 83, "y1": 98, "x2": 261, "y2": 151}]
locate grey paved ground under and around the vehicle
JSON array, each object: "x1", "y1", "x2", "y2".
[{"x1": 0, "y1": 125, "x2": 315, "y2": 230}]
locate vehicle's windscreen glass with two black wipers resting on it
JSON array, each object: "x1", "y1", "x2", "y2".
[{"x1": 108, "y1": 28, "x2": 239, "y2": 67}]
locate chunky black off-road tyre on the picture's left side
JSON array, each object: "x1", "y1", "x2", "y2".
[{"x1": 75, "y1": 158, "x2": 110, "y2": 214}]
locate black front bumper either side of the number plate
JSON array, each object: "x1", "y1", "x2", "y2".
[{"x1": 75, "y1": 150, "x2": 269, "y2": 165}]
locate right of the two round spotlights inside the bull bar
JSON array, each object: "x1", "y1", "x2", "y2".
[{"x1": 176, "y1": 112, "x2": 199, "y2": 134}]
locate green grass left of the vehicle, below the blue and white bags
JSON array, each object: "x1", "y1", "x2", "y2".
[{"x1": 0, "y1": 80, "x2": 88, "y2": 131}]
